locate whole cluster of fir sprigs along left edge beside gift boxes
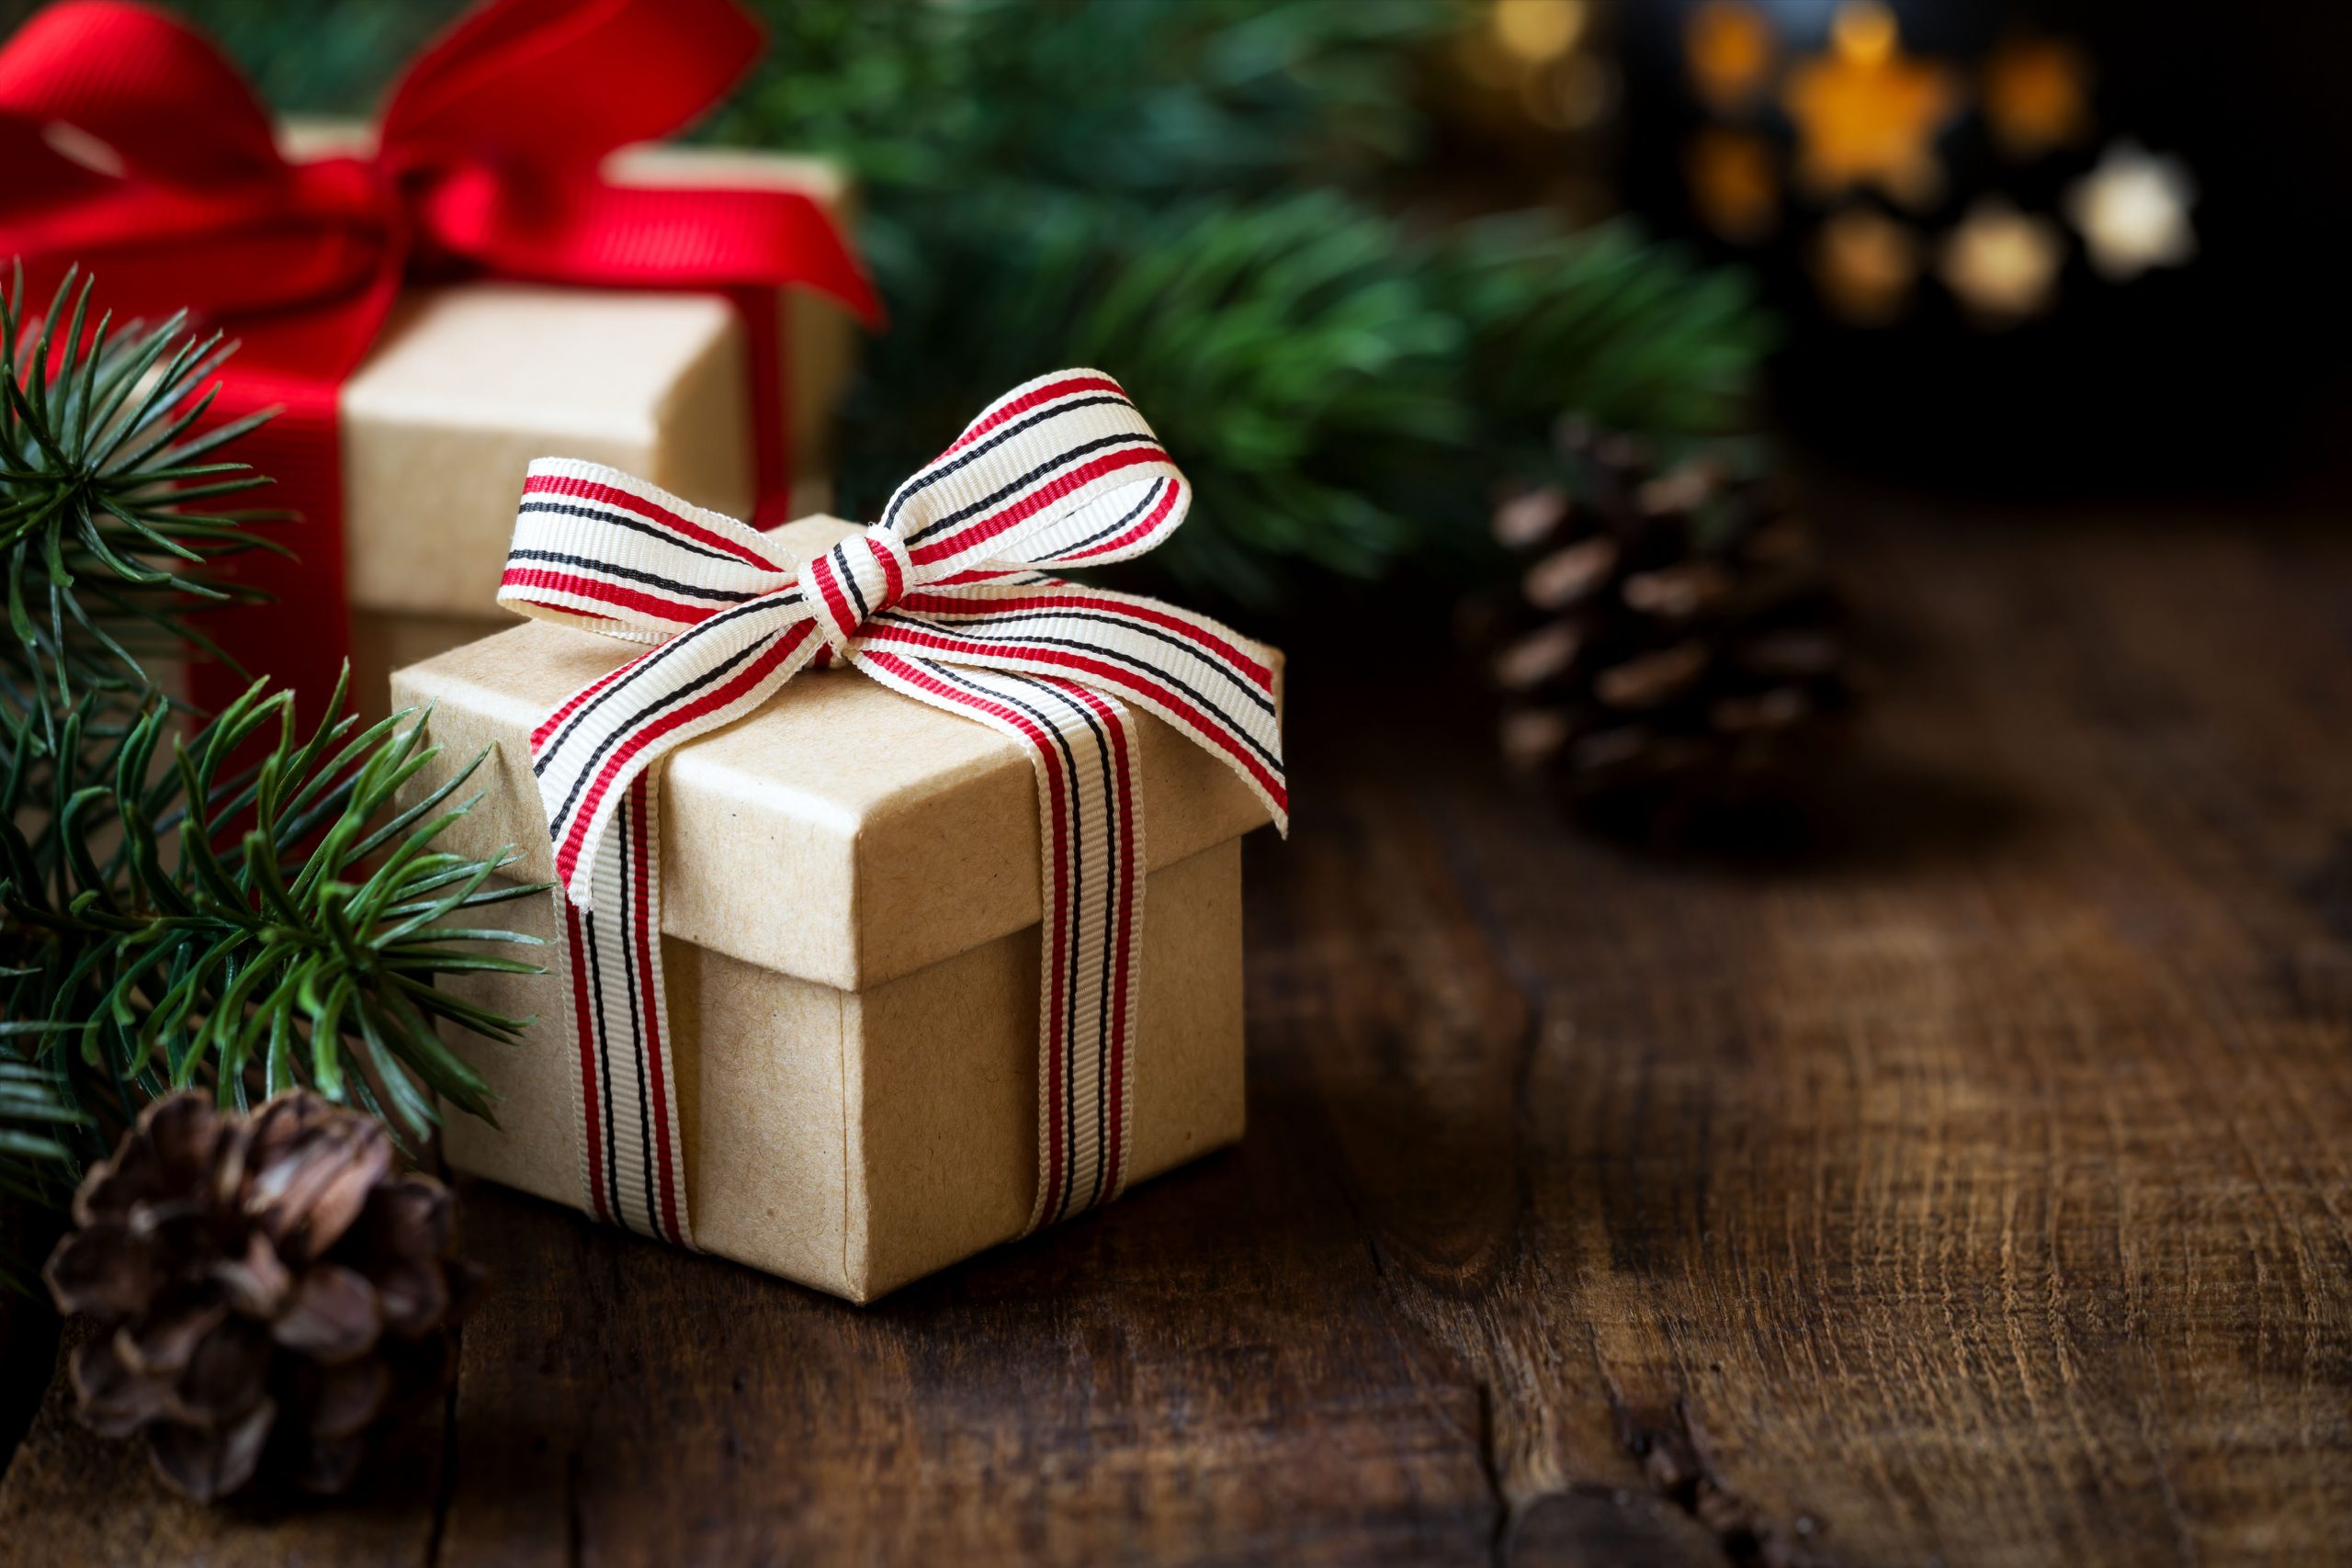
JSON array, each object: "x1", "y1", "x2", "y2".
[{"x1": 0, "y1": 277, "x2": 543, "y2": 1283}]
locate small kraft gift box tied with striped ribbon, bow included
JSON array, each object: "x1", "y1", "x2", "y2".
[{"x1": 393, "y1": 371, "x2": 1286, "y2": 1303}]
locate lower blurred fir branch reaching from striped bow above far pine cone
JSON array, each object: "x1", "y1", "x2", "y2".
[{"x1": 840, "y1": 190, "x2": 1769, "y2": 611}]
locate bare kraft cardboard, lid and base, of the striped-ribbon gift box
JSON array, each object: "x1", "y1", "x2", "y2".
[{"x1": 393, "y1": 520, "x2": 1268, "y2": 1303}]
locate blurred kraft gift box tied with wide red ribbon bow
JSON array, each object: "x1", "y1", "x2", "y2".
[{"x1": 0, "y1": 0, "x2": 877, "y2": 717}]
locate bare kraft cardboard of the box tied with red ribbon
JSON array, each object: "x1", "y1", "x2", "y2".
[{"x1": 280, "y1": 122, "x2": 856, "y2": 719}]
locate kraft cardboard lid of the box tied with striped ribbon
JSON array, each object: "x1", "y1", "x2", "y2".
[{"x1": 393, "y1": 517, "x2": 1265, "y2": 989}]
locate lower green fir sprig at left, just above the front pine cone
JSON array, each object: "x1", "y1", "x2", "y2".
[{"x1": 0, "y1": 667, "x2": 543, "y2": 1161}]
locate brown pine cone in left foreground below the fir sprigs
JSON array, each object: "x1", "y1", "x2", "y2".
[{"x1": 47, "y1": 1093, "x2": 480, "y2": 1502}]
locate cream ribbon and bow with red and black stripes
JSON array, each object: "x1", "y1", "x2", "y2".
[{"x1": 499, "y1": 369, "x2": 1289, "y2": 1246}]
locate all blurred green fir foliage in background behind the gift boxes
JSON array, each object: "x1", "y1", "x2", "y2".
[{"x1": 165, "y1": 0, "x2": 1767, "y2": 606}]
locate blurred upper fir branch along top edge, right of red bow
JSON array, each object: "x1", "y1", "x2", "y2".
[{"x1": 691, "y1": 0, "x2": 1470, "y2": 208}]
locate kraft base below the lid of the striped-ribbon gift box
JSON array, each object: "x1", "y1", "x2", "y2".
[{"x1": 442, "y1": 840, "x2": 1242, "y2": 1303}]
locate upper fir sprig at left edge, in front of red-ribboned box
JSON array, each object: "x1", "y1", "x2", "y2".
[{"x1": 0, "y1": 270, "x2": 277, "y2": 743}]
